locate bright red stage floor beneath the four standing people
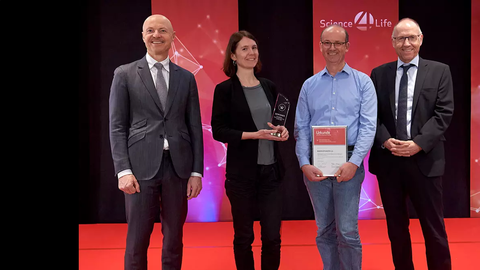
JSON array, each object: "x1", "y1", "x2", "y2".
[{"x1": 79, "y1": 218, "x2": 480, "y2": 270}]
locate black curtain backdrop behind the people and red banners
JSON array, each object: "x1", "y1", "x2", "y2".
[{"x1": 78, "y1": 0, "x2": 471, "y2": 223}]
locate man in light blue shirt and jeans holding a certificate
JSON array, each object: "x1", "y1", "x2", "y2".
[{"x1": 295, "y1": 25, "x2": 377, "y2": 269}]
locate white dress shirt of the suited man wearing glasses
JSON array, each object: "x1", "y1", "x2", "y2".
[{"x1": 395, "y1": 55, "x2": 419, "y2": 138}]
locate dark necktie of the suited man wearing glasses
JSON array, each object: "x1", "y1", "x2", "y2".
[{"x1": 397, "y1": 64, "x2": 413, "y2": 140}]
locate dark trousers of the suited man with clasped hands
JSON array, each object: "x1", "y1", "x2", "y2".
[{"x1": 377, "y1": 156, "x2": 452, "y2": 270}]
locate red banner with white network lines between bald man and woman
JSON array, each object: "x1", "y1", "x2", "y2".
[{"x1": 152, "y1": 0, "x2": 238, "y2": 222}]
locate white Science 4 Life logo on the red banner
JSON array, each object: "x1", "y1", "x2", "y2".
[{"x1": 320, "y1": 11, "x2": 393, "y2": 31}]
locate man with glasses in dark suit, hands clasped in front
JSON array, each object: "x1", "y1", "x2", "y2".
[{"x1": 369, "y1": 18, "x2": 453, "y2": 270}]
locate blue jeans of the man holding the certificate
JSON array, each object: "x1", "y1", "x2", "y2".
[{"x1": 303, "y1": 162, "x2": 365, "y2": 270}]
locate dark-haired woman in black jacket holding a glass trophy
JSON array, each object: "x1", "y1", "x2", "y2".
[{"x1": 211, "y1": 31, "x2": 289, "y2": 270}]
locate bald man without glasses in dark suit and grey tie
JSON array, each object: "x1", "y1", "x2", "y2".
[{"x1": 109, "y1": 15, "x2": 203, "y2": 270}]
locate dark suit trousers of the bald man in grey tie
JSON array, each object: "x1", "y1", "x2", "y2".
[{"x1": 125, "y1": 151, "x2": 188, "y2": 270}]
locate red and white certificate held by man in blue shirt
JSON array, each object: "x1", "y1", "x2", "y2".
[{"x1": 312, "y1": 126, "x2": 348, "y2": 176}]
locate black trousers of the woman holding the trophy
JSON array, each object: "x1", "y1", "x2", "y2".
[{"x1": 225, "y1": 163, "x2": 282, "y2": 270}]
